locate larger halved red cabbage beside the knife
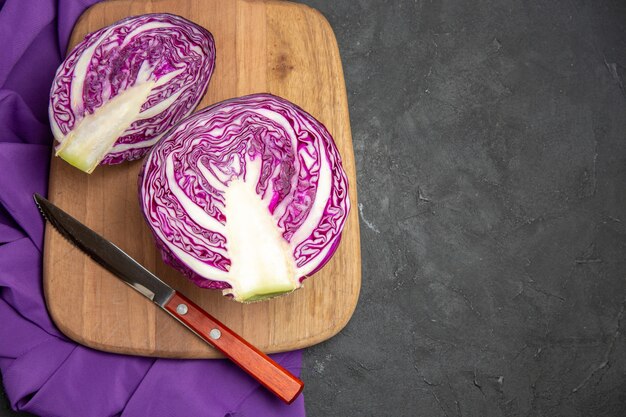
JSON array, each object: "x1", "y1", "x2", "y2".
[{"x1": 139, "y1": 94, "x2": 350, "y2": 302}]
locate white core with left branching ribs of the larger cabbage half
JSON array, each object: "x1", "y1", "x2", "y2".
[{"x1": 160, "y1": 151, "x2": 301, "y2": 301}]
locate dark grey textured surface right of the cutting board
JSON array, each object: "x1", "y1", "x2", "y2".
[{"x1": 0, "y1": 0, "x2": 626, "y2": 417}]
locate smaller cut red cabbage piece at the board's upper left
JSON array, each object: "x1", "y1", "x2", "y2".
[{"x1": 49, "y1": 13, "x2": 215, "y2": 173}]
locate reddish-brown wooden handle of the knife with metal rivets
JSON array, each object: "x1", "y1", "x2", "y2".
[{"x1": 165, "y1": 292, "x2": 304, "y2": 404}]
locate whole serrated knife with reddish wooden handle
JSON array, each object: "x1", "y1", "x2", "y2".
[{"x1": 34, "y1": 194, "x2": 304, "y2": 404}]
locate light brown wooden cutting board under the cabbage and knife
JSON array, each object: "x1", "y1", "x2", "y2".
[{"x1": 44, "y1": 0, "x2": 361, "y2": 358}]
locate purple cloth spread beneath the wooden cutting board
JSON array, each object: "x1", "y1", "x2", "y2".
[{"x1": 0, "y1": 0, "x2": 304, "y2": 417}]
